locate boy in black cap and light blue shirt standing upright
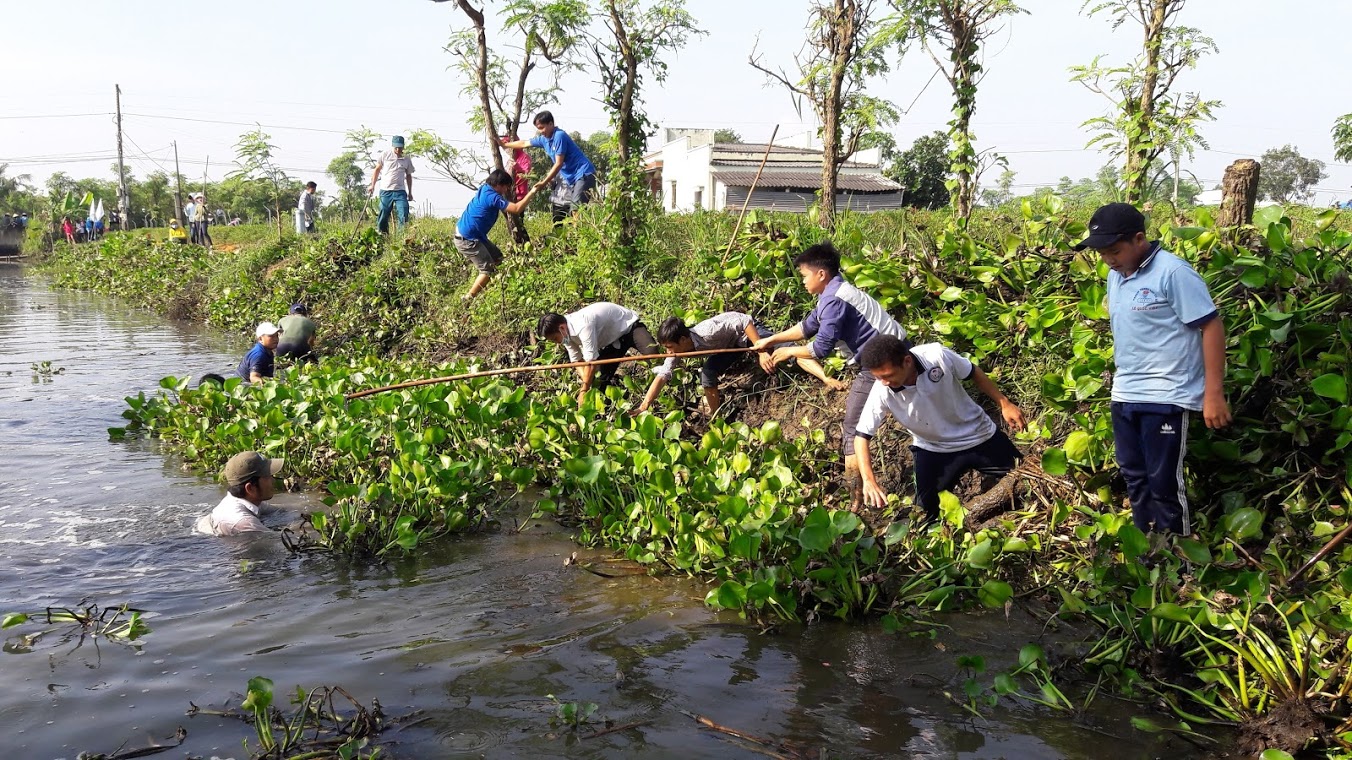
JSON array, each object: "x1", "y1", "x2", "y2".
[{"x1": 1075, "y1": 203, "x2": 1230, "y2": 534}]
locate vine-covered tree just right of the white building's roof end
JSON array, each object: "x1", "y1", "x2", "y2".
[{"x1": 891, "y1": 0, "x2": 1025, "y2": 219}]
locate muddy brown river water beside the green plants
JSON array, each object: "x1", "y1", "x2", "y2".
[{"x1": 0, "y1": 264, "x2": 1164, "y2": 759}]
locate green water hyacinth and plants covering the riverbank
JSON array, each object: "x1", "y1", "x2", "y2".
[{"x1": 34, "y1": 203, "x2": 1352, "y2": 752}]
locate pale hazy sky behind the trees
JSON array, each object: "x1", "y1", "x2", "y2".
[{"x1": 0, "y1": 0, "x2": 1352, "y2": 215}]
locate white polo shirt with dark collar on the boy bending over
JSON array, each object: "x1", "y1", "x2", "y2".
[{"x1": 854, "y1": 343, "x2": 996, "y2": 453}]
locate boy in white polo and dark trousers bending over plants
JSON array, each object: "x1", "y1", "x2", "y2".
[{"x1": 854, "y1": 334, "x2": 1023, "y2": 521}]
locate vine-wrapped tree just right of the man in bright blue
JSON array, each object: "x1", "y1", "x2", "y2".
[{"x1": 584, "y1": 0, "x2": 704, "y2": 268}]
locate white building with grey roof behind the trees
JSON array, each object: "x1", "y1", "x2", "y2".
[{"x1": 644, "y1": 128, "x2": 903, "y2": 212}]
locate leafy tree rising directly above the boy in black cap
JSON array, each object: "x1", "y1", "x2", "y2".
[{"x1": 1071, "y1": 0, "x2": 1221, "y2": 203}]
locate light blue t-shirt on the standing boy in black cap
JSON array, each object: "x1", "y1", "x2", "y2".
[{"x1": 1107, "y1": 243, "x2": 1215, "y2": 411}]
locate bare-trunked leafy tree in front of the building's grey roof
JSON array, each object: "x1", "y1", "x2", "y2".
[{"x1": 749, "y1": 0, "x2": 907, "y2": 229}]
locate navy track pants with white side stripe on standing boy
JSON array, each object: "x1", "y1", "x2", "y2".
[{"x1": 1113, "y1": 402, "x2": 1192, "y2": 536}]
